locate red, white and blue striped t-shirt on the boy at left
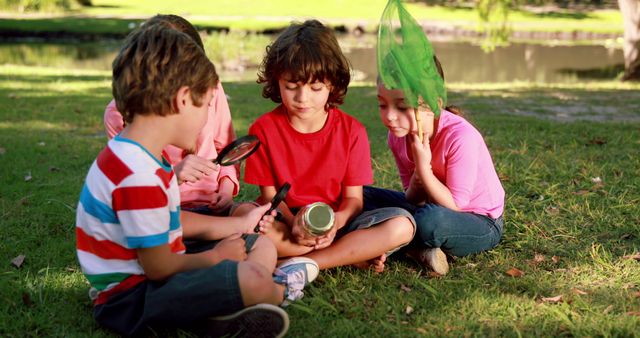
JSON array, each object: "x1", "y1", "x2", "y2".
[{"x1": 76, "y1": 135, "x2": 185, "y2": 305}]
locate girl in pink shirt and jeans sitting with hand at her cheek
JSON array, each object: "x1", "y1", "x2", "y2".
[{"x1": 364, "y1": 56, "x2": 504, "y2": 275}]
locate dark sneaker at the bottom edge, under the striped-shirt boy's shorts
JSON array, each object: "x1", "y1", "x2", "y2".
[{"x1": 206, "y1": 304, "x2": 289, "y2": 338}]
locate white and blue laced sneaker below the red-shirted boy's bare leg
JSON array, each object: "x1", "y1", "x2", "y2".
[{"x1": 273, "y1": 257, "x2": 320, "y2": 306}]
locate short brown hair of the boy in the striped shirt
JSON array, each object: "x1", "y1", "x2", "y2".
[{"x1": 112, "y1": 24, "x2": 218, "y2": 123}]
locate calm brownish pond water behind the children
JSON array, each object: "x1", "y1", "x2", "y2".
[{"x1": 0, "y1": 36, "x2": 624, "y2": 83}]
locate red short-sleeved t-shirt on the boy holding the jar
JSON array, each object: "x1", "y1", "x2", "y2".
[{"x1": 244, "y1": 105, "x2": 373, "y2": 210}]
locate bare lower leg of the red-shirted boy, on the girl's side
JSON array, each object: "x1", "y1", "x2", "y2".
[{"x1": 305, "y1": 217, "x2": 413, "y2": 269}]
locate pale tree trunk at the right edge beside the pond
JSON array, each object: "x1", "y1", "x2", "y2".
[{"x1": 618, "y1": 0, "x2": 640, "y2": 81}]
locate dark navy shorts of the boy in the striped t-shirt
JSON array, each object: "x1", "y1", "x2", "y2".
[{"x1": 93, "y1": 234, "x2": 258, "y2": 335}]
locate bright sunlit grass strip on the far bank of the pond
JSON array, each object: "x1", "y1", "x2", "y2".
[{"x1": 0, "y1": 0, "x2": 623, "y2": 34}]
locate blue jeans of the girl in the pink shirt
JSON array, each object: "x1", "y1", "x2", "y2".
[{"x1": 364, "y1": 186, "x2": 504, "y2": 256}]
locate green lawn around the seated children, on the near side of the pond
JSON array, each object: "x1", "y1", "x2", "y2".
[{"x1": 0, "y1": 66, "x2": 640, "y2": 337}]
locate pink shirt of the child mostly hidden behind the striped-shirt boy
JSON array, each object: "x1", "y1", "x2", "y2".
[{"x1": 104, "y1": 83, "x2": 239, "y2": 207}]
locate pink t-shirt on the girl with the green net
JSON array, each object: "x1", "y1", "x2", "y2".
[{"x1": 388, "y1": 110, "x2": 504, "y2": 218}]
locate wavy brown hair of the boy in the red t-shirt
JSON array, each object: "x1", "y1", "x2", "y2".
[{"x1": 257, "y1": 20, "x2": 351, "y2": 108}]
